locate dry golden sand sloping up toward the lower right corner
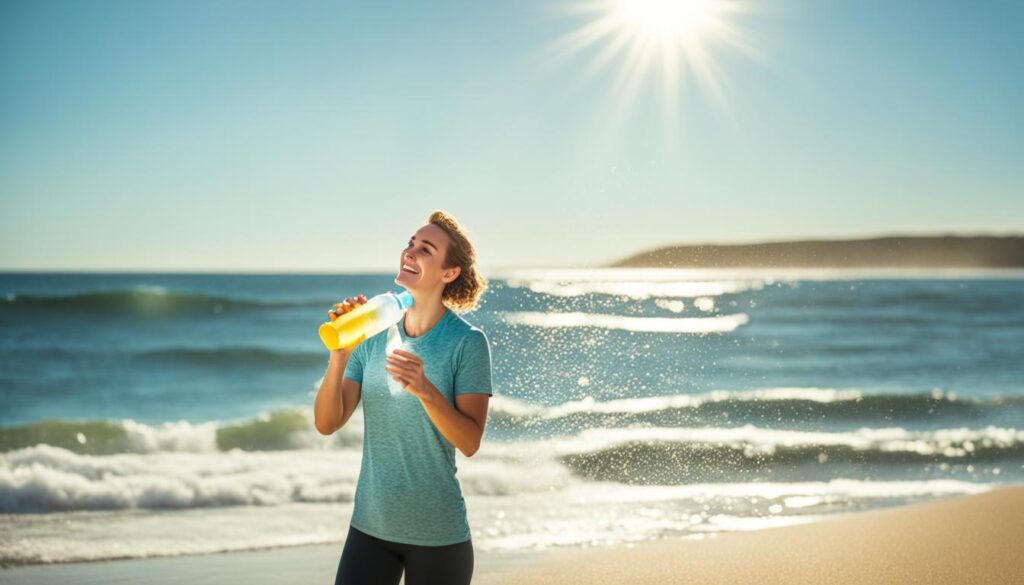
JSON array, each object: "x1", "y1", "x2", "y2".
[{"x1": 496, "y1": 487, "x2": 1024, "y2": 585}]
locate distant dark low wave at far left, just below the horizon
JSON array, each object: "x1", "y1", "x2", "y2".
[{"x1": 0, "y1": 287, "x2": 299, "y2": 315}]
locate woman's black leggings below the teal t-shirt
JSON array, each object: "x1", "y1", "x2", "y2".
[{"x1": 334, "y1": 525, "x2": 473, "y2": 585}]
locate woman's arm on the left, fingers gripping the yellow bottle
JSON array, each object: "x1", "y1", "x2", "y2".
[{"x1": 313, "y1": 295, "x2": 367, "y2": 434}]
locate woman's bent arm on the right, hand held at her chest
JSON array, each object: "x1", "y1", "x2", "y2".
[{"x1": 384, "y1": 349, "x2": 490, "y2": 457}]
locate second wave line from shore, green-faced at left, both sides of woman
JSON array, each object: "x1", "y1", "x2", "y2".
[{"x1": 9, "y1": 387, "x2": 1024, "y2": 455}]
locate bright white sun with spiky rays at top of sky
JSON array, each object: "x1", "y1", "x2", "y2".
[{"x1": 554, "y1": 0, "x2": 757, "y2": 121}]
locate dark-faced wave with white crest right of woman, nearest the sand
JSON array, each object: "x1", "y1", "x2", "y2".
[{"x1": 552, "y1": 425, "x2": 1024, "y2": 485}]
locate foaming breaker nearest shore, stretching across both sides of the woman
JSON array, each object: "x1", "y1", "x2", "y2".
[{"x1": 16, "y1": 415, "x2": 1007, "y2": 513}]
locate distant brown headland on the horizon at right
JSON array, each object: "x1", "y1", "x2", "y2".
[{"x1": 607, "y1": 236, "x2": 1024, "y2": 268}]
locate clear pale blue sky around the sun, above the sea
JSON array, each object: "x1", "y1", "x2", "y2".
[{"x1": 0, "y1": 0, "x2": 1024, "y2": 271}]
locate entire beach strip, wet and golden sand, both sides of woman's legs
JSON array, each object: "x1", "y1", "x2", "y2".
[{"x1": 0, "y1": 486, "x2": 1024, "y2": 585}]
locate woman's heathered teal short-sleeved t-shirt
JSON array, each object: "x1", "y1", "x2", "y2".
[{"x1": 344, "y1": 307, "x2": 493, "y2": 546}]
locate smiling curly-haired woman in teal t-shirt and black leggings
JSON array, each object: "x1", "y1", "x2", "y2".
[{"x1": 314, "y1": 211, "x2": 492, "y2": 585}]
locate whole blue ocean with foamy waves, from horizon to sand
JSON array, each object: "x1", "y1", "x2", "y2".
[{"x1": 0, "y1": 268, "x2": 1024, "y2": 566}]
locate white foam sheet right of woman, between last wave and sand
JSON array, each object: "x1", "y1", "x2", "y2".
[{"x1": 468, "y1": 479, "x2": 991, "y2": 550}]
